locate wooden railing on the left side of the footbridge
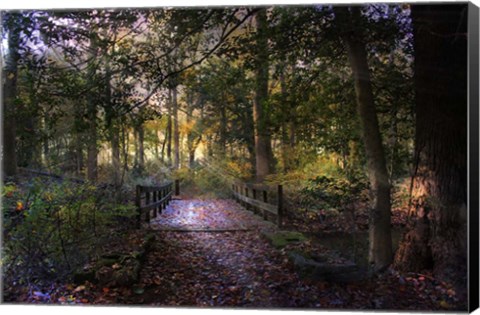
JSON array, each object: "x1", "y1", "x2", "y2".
[{"x1": 135, "y1": 180, "x2": 180, "y2": 228}]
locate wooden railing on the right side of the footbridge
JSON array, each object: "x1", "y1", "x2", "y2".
[{"x1": 232, "y1": 182, "x2": 283, "y2": 226}]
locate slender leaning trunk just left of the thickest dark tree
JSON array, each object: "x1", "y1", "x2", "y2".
[{"x1": 335, "y1": 7, "x2": 393, "y2": 270}]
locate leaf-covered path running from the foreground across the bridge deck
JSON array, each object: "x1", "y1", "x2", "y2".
[{"x1": 132, "y1": 200, "x2": 320, "y2": 307}]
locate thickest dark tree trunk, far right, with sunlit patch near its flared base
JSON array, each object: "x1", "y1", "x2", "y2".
[{"x1": 395, "y1": 4, "x2": 468, "y2": 286}]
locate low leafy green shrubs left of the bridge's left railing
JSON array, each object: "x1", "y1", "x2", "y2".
[{"x1": 3, "y1": 179, "x2": 135, "y2": 283}]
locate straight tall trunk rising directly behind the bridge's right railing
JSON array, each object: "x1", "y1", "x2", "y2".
[{"x1": 253, "y1": 9, "x2": 271, "y2": 182}]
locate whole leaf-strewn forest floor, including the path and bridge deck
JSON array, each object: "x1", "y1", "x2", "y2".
[{"x1": 5, "y1": 200, "x2": 465, "y2": 310}]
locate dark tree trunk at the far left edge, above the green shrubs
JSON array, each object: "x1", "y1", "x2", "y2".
[{"x1": 3, "y1": 13, "x2": 21, "y2": 176}]
